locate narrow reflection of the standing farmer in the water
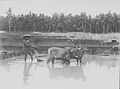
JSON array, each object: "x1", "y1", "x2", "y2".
[{"x1": 23, "y1": 62, "x2": 32, "y2": 84}]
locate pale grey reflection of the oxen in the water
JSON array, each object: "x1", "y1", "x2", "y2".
[{"x1": 48, "y1": 65, "x2": 86, "y2": 81}]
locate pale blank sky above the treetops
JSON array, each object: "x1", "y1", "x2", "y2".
[{"x1": 0, "y1": 0, "x2": 120, "y2": 16}]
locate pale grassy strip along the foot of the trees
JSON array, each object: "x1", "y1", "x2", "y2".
[{"x1": 0, "y1": 32, "x2": 120, "y2": 41}]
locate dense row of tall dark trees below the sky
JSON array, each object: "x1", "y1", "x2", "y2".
[{"x1": 0, "y1": 8, "x2": 120, "y2": 33}]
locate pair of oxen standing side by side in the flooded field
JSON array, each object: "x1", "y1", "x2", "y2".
[{"x1": 47, "y1": 47, "x2": 88, "y2": 65}]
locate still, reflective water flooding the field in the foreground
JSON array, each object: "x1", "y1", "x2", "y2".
[{"x1": 0, "y1": 55, "x2": 120, "y2": 89}]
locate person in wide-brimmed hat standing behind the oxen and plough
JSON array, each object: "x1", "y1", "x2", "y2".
[{"x1": 23, "y1": 34, "x2": 33, "y2": 62}]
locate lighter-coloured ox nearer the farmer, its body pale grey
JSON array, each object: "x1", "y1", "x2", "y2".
[{"x1": 47, "y1": 47, "x2": 71, "y2": 64}]
